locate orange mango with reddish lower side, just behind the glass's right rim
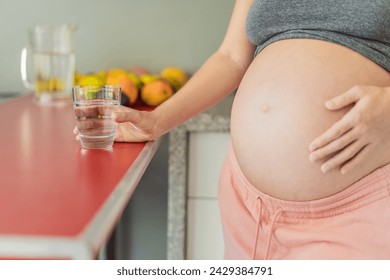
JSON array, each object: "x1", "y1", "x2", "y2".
[{"x1": 106, "y1": 68, "x2": 138, "y2": 105}]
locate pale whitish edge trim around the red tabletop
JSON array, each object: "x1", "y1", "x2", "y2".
[{"x1": 0, "y1": 139, "x2": 162, "y2": 260}]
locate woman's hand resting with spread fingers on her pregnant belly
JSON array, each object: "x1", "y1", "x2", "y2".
[{"x1": 309, "y1": 86, "x2": 390, "y2": 174}]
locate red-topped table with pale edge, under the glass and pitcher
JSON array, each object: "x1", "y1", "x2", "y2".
[{"x1": 0, "y1": 95, "x2": 159, "y2": 259}]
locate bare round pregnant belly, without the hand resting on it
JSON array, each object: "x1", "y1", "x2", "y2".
[{"x1": 231, "y1": 39, "x2": 390, "y2": 201}]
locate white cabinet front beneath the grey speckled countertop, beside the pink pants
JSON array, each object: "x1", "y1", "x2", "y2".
[{"x1": 186, "y1": 132, "x2": 230, "y2": 260}]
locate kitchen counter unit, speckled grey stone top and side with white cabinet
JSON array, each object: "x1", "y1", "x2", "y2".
[{"x1": 167, "y1": 94, "x2": 232, "y2": 260}]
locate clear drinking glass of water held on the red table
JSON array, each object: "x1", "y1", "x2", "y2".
[{"x1": 73, "y1": 85, "x2": 121, "y2": 150}]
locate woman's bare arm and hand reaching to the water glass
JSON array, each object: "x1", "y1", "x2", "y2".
[{"x1": 74, "y1": 0, "x2": 255, "y2": 142}]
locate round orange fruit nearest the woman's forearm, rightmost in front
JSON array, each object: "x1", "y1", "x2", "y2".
[{"x1": 141, "y1": 80, "x2": 173, "y2": 106}]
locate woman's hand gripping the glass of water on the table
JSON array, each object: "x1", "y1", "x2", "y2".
[{"x1": 73, "y1": 106, "x2": 161, "y2": 142}]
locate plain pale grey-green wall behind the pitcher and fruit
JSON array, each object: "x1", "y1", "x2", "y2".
[{"x1": 0, "y1": 0, "x2": 234, "y2": 94}]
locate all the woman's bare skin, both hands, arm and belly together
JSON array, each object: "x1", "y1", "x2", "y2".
[{"x1": 74, "y1": 0, "x2": 390, "y2": 201}]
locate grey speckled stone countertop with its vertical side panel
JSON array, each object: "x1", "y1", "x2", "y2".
[{"x1": 167, "y1": 94, "x2": 234, "y2": 259}]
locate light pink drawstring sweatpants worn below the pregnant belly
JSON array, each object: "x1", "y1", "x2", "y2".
[{"x1": 219, "y1": 144, "x2": 390, "y2": 260}]
